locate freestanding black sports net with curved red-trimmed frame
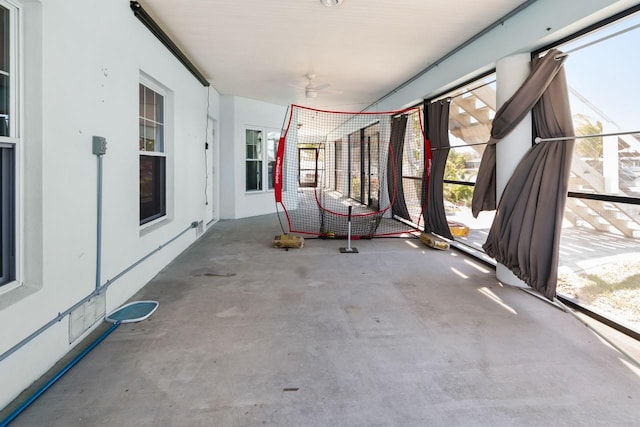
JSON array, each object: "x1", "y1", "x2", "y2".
[{"x1": 273, "y1": 105, "x2": 431, "y2": 238}]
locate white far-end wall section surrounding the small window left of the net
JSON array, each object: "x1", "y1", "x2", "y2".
[{"x1": 221, "y1": 96, "x2": 287, "y2": 218}]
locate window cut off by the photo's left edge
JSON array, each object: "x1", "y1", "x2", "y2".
[{"x1": 0, "y1": 0, "x2": 20, "y2": 286}]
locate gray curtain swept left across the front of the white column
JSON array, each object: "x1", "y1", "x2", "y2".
[{"x1": 471, "y1": 49, "x2": 566, "y2": 217}]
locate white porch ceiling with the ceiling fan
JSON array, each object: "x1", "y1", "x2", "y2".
[{"x1": 140, "y1": 0, "x2": 525, "y2": 111}]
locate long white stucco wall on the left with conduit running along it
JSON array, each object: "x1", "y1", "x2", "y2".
[{"x1": 0, "y1": 0, "x2": 220, "y2": 407}]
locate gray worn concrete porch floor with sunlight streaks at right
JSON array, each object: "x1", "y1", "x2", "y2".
[{"x1": 5, "y1": 215, "x2": 640, "y2": 427}]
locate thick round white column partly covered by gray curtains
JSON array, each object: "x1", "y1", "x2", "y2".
[{"x1": 496, "y1": 53, "x2": 533, "y2": 287}]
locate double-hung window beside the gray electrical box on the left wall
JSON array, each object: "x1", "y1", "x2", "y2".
[{"x1": 138, "y1": 81, "x2": 167, "y2": 225}]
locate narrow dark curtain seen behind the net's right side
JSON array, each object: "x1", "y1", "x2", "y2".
[{"x1": 387, "y1": 115, "x2": 411, "y2": 220}]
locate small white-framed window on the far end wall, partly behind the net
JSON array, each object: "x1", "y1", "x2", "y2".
[{"x1": 245, "y1": 128, "x2": 280, "y2": 192}]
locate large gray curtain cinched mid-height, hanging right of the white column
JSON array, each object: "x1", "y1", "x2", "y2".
[{"x1": 483, "y1": 51, "x2": 575, "y2": 299}]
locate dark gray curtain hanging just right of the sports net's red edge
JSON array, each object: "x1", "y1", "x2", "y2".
[{"x1": 422, "y1": 99, "x2": 453, "y2": 240}]
